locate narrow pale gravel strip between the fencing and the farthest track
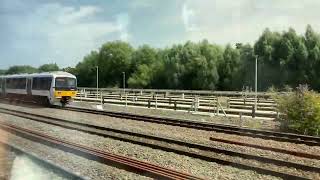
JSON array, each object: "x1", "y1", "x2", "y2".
[{"x1": 71, "y1": 102, "x2": 280, "y2": 130}]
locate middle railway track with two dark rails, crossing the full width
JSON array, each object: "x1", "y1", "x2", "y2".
[{"x1": 0, "y1": 108, "x2": 320, "y2": 179}]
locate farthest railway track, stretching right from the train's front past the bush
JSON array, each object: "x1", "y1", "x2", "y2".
[{"x1": 64, "y1": 107, "x2": 320, "y2": 146}]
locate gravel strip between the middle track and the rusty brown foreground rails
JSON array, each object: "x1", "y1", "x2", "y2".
[{"x1": 1, "y1": 114, "x2": 276, "y2": 179}]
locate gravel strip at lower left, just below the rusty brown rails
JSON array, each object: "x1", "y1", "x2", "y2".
[{"x1": 0, "y1": 129, "x2": 150, "y2": 179}]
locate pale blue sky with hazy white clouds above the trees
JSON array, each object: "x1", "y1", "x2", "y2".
[{"x1": 0, "y1": 0, "x2": 320, "y2": 69}]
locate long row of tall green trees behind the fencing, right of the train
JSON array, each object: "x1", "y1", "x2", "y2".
[{"x1": 1, "y1": 26, "x2": 320, "y2": 91}]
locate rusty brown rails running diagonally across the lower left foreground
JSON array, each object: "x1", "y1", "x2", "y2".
[{"x1": 0, "y1": 122, "x2": 202, "y2": 180}]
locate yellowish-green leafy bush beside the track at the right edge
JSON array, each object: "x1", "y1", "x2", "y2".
[{"x1": 275, "y1": 86, "x2": 320, "y2": 136}]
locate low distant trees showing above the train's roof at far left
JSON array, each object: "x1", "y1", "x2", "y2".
[{"x1": 0, "y1": 63, "x2": 64, "y2": 75}]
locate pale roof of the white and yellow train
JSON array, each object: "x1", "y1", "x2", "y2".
[{"x1": 0, "y1": 71, "x2": 76, "y2": 78}]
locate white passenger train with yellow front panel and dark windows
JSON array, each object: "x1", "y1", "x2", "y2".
[{"x1": 0, "y1": 71, "x2": 77, "y2": 106}]
